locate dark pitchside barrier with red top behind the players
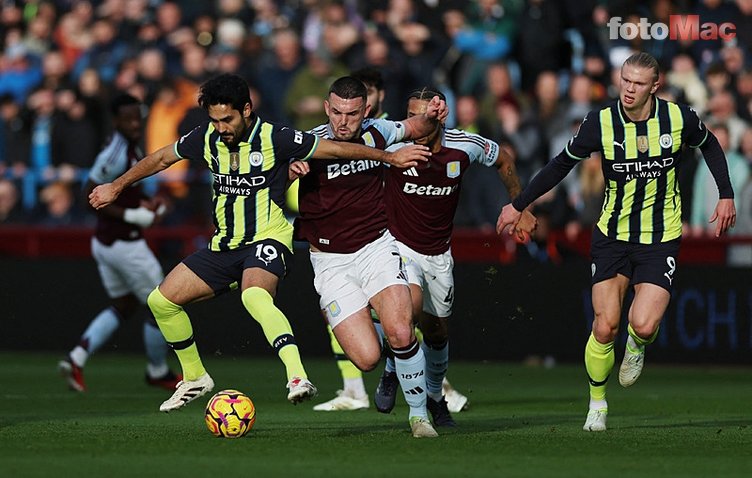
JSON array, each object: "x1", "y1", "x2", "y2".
[{"x1": 0, "y1": 226, "x2": 752, "y2": 364}]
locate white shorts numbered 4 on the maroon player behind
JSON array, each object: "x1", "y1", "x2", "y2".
[{"x1": 397, "y1": 241, "x2": 454, "y2": 317}]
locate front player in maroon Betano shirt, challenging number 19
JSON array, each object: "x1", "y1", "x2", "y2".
[{"x1": 291, "y1": 76, "x2": 447, "y2": 438}]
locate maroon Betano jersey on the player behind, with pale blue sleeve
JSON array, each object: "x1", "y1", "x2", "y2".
[{"x1": 386, "y1": 130, "x2": 499, "y2": 256}]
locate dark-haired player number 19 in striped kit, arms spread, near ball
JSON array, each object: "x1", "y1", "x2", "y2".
[{"x1": 89, "y1": 74, "x2": 427, "y2": 412}]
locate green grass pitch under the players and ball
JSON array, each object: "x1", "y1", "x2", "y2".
[{"x1": 0, "y1": 353, "x2": 752, "y2": 478}]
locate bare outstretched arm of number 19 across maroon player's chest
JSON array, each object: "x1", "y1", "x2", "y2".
[{"x1": 312, "y1": 139, "x2": 431, "y2": 168}]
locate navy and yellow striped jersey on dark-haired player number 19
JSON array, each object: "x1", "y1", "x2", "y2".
[{"x1": 174, "y1": 115, "x2": 319, "y2": 251}]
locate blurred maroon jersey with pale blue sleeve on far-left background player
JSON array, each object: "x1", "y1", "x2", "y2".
[{"x1": 89, "y1": 132, "x2": 146, "y2": 245}]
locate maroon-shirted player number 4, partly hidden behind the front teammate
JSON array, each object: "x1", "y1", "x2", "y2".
[{"x1": 374, "y1": 88, "x2": 535, "y2": 426}]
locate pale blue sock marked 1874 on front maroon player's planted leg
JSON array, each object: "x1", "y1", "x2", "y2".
[{"x1": 392, "y1": 340, "x2": 428, "y2": 418}]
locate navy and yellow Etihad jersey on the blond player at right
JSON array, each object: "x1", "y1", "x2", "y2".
[{"x1": 564, "y1": 97, "x2": 708, "y2": 244}]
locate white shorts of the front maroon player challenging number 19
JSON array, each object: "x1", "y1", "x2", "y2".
[{"x1": 311, "y1": 231, "x2": 408, "y2": 328}]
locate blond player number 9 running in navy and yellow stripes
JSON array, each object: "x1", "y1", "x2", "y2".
[{"x1": 496, "y1": 52, "x2": 736, "y2": 431}]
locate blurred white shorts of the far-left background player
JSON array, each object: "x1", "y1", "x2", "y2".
[{"x1": 91, "y1": 238, "x2": 164, "y2": 304}]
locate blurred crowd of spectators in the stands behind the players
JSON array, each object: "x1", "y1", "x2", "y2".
[{"x1": 0, "y1": 0, "x2": 752, "y2": 260}]
